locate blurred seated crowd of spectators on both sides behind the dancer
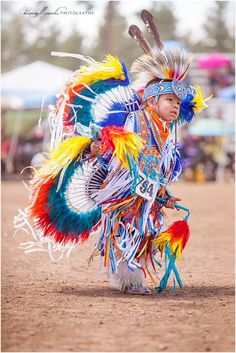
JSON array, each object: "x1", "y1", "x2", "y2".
[{"x1": 1, "y1": 125, "x2": 234, "y2": 182}]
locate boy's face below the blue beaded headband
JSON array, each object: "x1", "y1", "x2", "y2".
[{"x1": 156, "y1": 93, "x2": 181, "y2": 122}]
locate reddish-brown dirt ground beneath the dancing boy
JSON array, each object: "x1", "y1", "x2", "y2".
[{"x1": 2, "y1": 181, "x2": 234, "y2": 352}]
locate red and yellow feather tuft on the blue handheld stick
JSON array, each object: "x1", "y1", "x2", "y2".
[{"x1": 153, "y1": 220, "x2": 190, "y2": 258}]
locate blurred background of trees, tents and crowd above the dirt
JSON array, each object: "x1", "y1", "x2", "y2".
[{"x1": 1, "y1": 0, "x2": 235, "y2": 183}]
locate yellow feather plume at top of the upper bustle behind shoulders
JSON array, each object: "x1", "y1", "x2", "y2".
[{"x1": 72, "y1": 55, "x2": 125, "y2": 87}]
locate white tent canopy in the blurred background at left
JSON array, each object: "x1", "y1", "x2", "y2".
[{"x1": 2, "y1": 61, "x2": 72, "y2": 108}]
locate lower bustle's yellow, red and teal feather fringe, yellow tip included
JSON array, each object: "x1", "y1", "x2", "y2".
[{"x1": 29, "y1": 136, "x2": 101, "y2": 244}]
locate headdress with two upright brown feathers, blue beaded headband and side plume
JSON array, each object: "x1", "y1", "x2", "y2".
[{"x1": 128, "y1": 10, "x2": 212, "y2": 122}]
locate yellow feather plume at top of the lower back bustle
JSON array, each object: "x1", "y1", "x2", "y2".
[{"x1": 36, "y1": 136, "x2": 91, "y2": 177}]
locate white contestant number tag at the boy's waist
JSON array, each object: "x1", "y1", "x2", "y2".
[{"x1": 135, "y1": 170, "x2": 158, "y2": 201}]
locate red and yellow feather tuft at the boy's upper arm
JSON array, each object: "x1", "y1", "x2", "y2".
[{"x1": 102, "y1": 126, "x2": 144, "y2": 168}]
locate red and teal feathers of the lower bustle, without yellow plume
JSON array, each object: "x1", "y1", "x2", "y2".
[{"x1": 29, "y1": 161, "x2": 101, "y2": 244}]
